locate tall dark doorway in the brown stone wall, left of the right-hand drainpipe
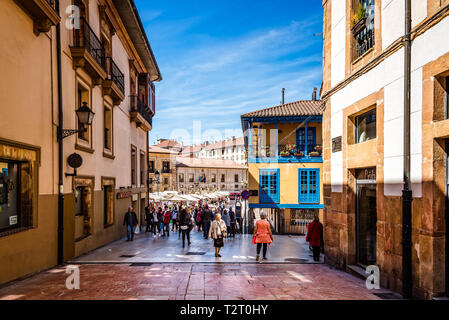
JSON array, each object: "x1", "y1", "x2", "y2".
[{"x1": 356, "y1": 183, "x2": 377, "y2": 266}]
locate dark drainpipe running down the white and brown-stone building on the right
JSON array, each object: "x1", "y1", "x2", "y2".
[{"x1": 402, "y1": 0, "x2": 413, "y2": 299}]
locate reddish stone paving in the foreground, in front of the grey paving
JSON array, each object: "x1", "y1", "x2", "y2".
[{"x1": 0, "y1": 263, "x2": 388, "y2": 300}]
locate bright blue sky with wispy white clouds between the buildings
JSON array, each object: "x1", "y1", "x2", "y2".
[{"x1": 135, "y1": 0, "x2": 323, "y2": 144}]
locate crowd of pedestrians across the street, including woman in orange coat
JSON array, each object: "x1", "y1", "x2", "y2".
[{"x1": 123, "y1": 202, "x2": 323, "y2": 261}]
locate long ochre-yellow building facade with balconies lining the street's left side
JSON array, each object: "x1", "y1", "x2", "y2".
[{"x1": 0, "y1": 0, "x2": 161, "y2": 284}]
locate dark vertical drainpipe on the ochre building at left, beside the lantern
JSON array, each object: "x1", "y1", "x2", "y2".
[{"x1": 56, "y1": 0, "x2": 64, "y2": 265}]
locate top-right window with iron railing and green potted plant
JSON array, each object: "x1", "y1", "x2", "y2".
[{"x1": 351, "y1": 0, "x2": 374, "y2": 59}]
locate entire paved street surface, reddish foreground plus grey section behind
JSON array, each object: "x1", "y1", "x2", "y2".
[{"x1": 0, "y1": 228, "x2": 396, "y2": 300}]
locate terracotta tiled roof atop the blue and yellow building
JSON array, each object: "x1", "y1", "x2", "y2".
[{"x1": 241, "y1": 100, "x2": 324, "y2": 118}]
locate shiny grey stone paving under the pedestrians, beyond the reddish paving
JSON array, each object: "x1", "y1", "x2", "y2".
[{"x1": 71, "y1": 226, "x2": 323, "y2": 263}]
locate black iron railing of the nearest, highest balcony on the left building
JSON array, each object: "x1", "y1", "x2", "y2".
[{"x1": 73, "y1": 18, "x2": 106, "y2": 71}]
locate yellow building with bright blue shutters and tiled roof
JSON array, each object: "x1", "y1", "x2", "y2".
[{"x1": 241, "y1": 100, "x2": 324, "y2": 234}]
